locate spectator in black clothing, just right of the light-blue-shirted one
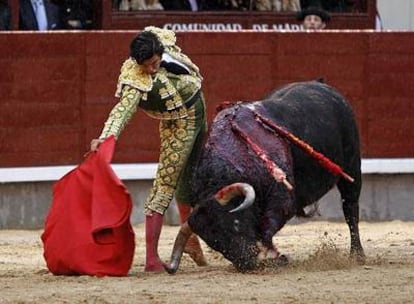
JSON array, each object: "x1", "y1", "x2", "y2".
[{"x1": 64, "y1": 0, "x2": 94, "y2": 30}]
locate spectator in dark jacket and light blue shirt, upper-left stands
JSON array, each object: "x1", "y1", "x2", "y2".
[{"x1": 19, "y1": 0, "x2": 65, "y2": 31}]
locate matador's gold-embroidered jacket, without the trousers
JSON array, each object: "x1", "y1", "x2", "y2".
[{"x1": 99, "y1": 27, "x2": 202, "y2": 139}]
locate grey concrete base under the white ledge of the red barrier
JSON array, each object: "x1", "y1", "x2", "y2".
[{"x1": 0, "y1": 174, "x2": 414, "y2": 229}]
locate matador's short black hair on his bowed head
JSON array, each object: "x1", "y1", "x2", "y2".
[{"x1": 129, "y1": 31, "x2": 164, "y2": 64}]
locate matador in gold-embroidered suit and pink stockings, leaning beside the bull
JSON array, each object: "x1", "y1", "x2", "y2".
[{"x1": 91, "y1": 26, "x2": 207, "y2": 272}]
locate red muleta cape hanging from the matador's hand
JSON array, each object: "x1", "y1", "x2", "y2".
[{"x1": 41, "y1": 136, "x2": 135, "y2": 276}]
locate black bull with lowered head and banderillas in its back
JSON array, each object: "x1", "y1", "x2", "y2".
[{"x1": 165, "y1": 81, "x2": 364, "y2": 273}]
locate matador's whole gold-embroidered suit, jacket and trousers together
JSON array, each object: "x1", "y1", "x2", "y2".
[{"x1": 99, "y1": 27, "x2": 207, "y2": 214}]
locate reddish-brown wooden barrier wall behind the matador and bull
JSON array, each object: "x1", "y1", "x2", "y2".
[{"x1": 0, "y1": 31, "x2": 414, "y2": 167}]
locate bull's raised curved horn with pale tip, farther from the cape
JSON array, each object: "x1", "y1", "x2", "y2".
[{"x1": 214, "y1": 183, "x2": 256, "y2": 212}]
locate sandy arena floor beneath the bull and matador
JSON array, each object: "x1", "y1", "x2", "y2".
[{"x1": 0, "y1": 221, "x2": 414, "y2": 304}]
